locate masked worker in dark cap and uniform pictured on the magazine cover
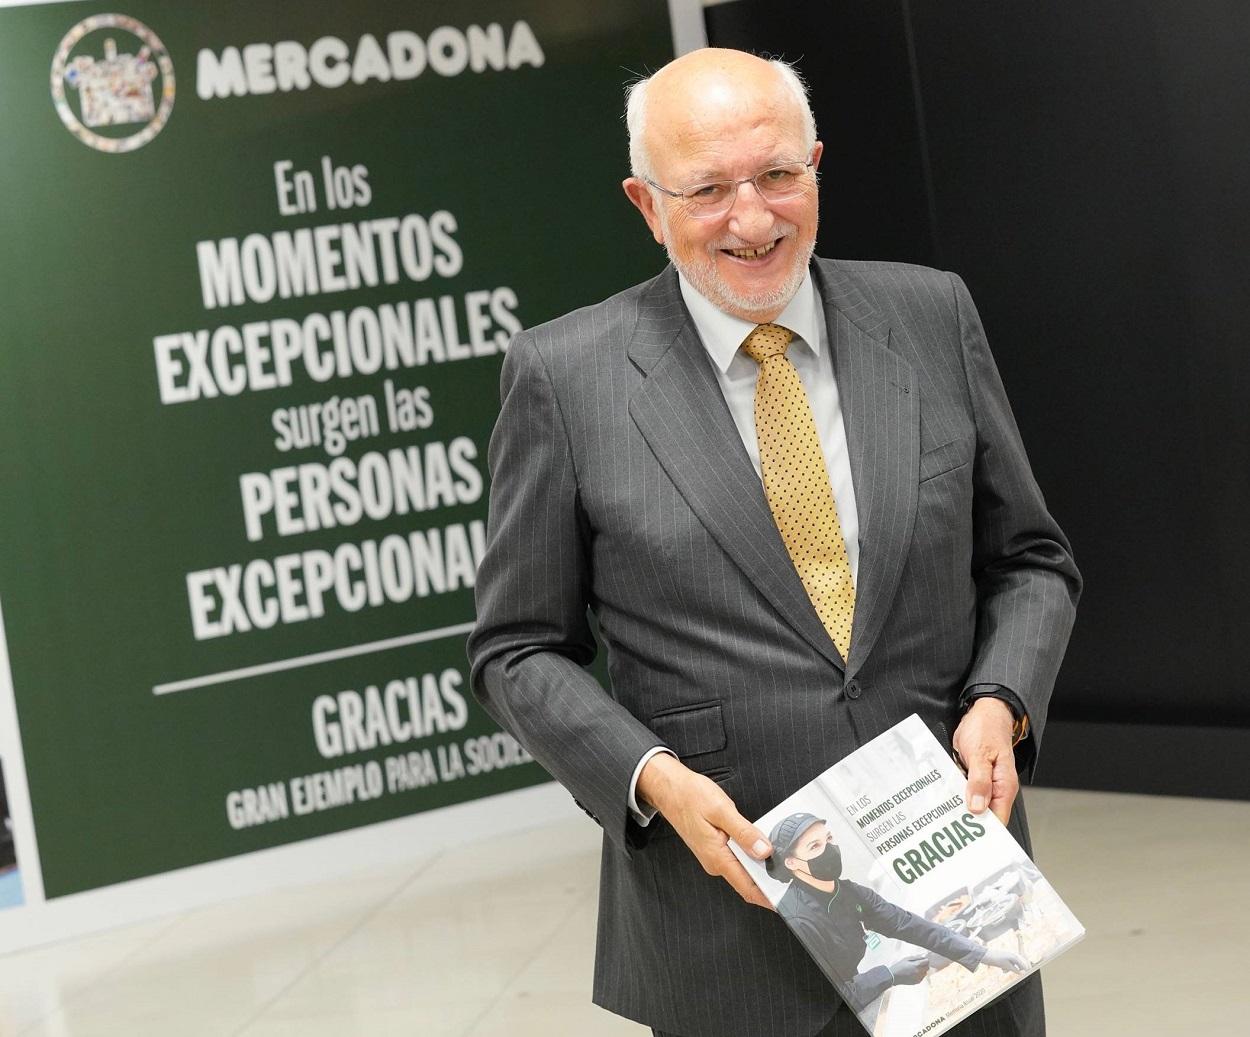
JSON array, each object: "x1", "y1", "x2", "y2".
[{"x1": 766, "y1": 813, "x2": 1029, "y2": 1012}]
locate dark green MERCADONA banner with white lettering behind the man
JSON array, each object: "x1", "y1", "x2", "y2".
[{"x1": 0, "y1": 0, "x2": 671, "y2": 897}]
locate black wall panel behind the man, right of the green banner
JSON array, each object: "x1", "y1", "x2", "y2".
[{"x1": 708, "y1": 0, "x2": 1250, "y2": 793}]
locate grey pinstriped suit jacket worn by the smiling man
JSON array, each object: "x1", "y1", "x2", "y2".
[{"x1": 469, "y1": 260, "x2": 1080, "y2": 1037}]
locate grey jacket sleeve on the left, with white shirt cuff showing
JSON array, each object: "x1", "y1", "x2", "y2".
[{"x1": 469, "y1": 332, "x2": 663, "y2": 852}]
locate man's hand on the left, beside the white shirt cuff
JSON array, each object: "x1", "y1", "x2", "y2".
[{"x1": 636, "y1": 752, "x2": 773, "y2": 911}]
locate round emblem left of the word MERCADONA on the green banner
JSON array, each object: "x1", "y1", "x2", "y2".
[{"x1": 51, "y1": 15, "x2": 174, "y2": 154}]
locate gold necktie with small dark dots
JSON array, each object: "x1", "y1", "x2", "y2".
[{"x1": 743, "y1": 324, "x2": 855, "y2": 660}]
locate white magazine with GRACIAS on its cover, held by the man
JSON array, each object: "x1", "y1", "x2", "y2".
[{"x1": 730, "y1": 715, "x2": 1085, "y2": 1037}]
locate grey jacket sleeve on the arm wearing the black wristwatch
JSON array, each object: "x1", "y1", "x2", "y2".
[{"x1": 950, "y1": 274, "x2": 1081, "y2": 777}]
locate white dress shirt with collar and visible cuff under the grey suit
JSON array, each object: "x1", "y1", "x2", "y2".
[{"x1": 629, "y1": 270, "x2": 859, "y2": 825}]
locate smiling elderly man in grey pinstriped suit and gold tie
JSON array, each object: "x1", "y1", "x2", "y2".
[{"x1": 469, "y1": 49, "x2": 1080, "y2": 1037}]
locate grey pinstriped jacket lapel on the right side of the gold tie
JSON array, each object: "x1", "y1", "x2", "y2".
[{"x1": 813, "y1": 261, "x2": 920, "y2": 675}]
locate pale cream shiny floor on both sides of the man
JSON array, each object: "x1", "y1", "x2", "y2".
[{"x1": 0, "y1": 790, "x2": 1250, "y2": 1037}]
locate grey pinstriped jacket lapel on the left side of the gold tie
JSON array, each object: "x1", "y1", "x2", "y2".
[{"x1": 629, "y1": 269, "x2": 858, "y2": 668}]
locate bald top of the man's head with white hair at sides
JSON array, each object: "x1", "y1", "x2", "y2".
[{"x1": 626, "y1": 47, "x2": 816, "y2": 180}]
